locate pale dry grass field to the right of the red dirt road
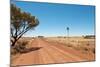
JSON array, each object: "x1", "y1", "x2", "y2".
[{"x1": 46, "y1": 37, "x2": 95, "y2": 54}]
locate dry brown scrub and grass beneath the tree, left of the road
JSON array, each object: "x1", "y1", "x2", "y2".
[{"x1": 11, "y1": 37, "x2": 32, "y2": 55}]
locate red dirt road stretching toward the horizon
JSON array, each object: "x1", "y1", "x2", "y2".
[{"x1": 11, "y1": 38, "x2": 94, "y2": 66}]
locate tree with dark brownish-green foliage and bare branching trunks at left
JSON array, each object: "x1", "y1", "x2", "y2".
[{"x1": 11, "y1": 4, "x2": 39, "y2": 46}]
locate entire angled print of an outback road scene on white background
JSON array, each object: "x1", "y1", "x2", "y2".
[{"x1": 10, "y1": 0, "x2": 95, "y2": 67}]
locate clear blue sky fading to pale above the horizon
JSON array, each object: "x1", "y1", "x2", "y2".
[{"x1": 13, "y1": 1, "x2": 95, "y2": 36}]
